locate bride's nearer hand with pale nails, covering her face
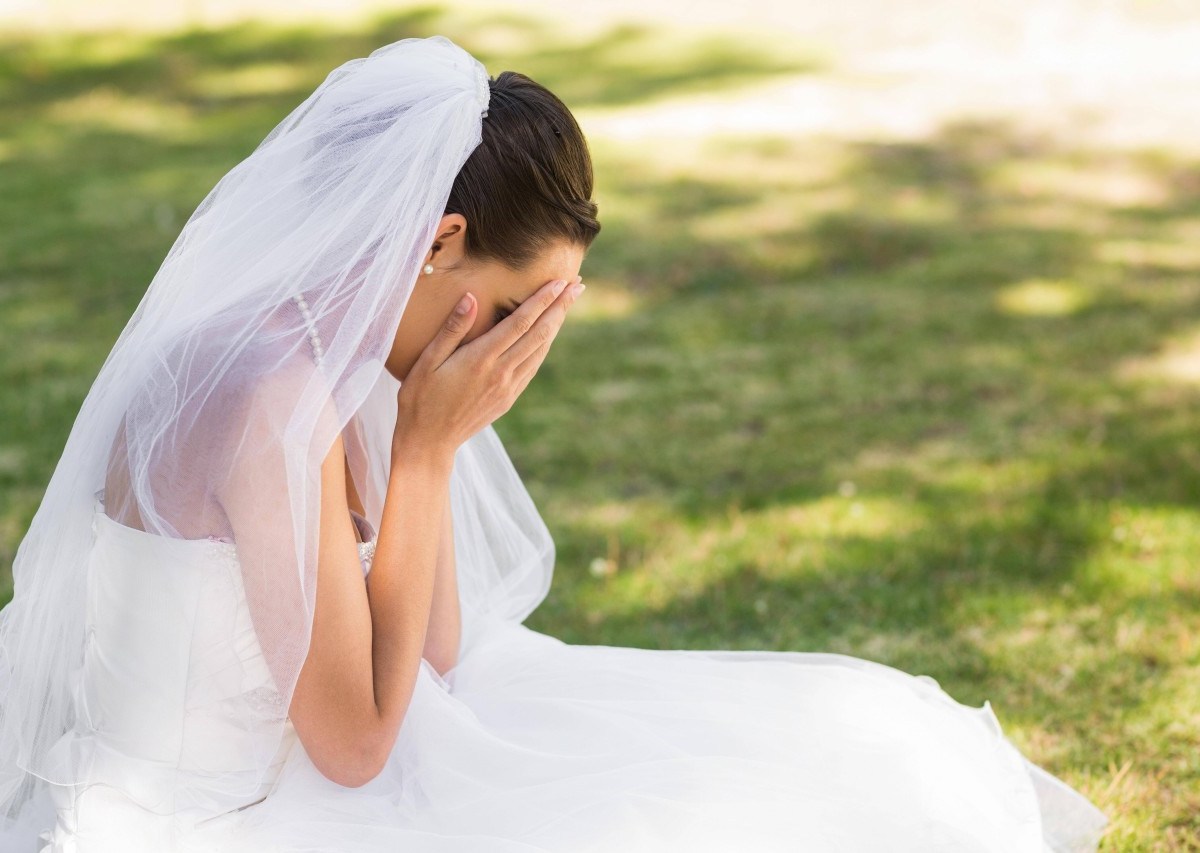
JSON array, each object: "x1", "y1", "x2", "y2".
[{"x1": 392, "y1": 276, "x2": 582, "y2": 456}]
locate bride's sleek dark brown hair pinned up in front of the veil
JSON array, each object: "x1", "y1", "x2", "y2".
[{"x1": 445, "y1": 71, "x2": 600, "y2": 270}]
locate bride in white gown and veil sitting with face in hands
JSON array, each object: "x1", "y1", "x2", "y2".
[{"x1": 0, "y1": 36, "x2": 1106, "y2": 853}]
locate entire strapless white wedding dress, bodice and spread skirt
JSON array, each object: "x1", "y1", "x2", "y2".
[{"x1": 22, "y1": 493, "x2": 1106, "y2": 853}]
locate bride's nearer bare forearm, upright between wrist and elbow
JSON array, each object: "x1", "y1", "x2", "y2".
[{"x1": 367, "y1": 436, "x2": 454, "y2": 755}]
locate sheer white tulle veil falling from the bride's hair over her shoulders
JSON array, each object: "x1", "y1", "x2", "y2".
[{"x1": 0, "y1": 36, "x2": 554, "y2": 830}]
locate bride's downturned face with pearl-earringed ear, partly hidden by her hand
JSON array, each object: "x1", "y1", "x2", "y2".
[{"x1": 385, "y1": 214, "x2": 584, "y2": 380}]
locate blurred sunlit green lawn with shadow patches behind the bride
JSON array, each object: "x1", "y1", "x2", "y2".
[{"x1": 0, "y1": 0, "x2": 1200, "y2": 851}]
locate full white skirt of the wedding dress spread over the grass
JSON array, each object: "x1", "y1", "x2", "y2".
[{"x1": 112, "y1": 623, "x2": 1106, "y2": 853}]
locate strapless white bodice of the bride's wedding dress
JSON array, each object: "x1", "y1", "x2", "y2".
[{"x1": 39, "y1": 492, "x2": 377, "y2": 839}]
